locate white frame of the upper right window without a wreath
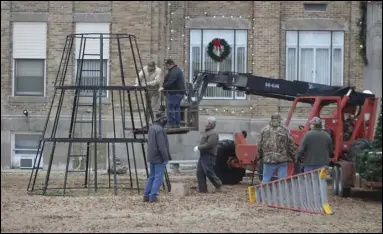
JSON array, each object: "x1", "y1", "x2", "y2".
[{"x1": 285, "y1": 30, "x2": 345, "y2": 86}]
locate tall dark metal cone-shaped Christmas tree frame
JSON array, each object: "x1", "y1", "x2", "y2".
[{"x1": 27, "y1": 33, "x2": 171, "y2": 195}]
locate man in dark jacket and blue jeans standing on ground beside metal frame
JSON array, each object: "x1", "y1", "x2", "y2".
[{"x1": 144, "y1": 112, "x2": 171, "y2": 202}]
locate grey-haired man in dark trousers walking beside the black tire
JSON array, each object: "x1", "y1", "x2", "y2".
[{"x1": 194, "y1": 117, "x2": 222, "y2": 193}]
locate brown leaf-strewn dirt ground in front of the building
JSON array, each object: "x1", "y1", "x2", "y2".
[{"x1": 1, "y1": 172, "x2": 382, "y2": 233}]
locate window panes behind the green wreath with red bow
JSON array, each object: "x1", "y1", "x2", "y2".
[{"x1": 189, "y1": 29, "x2": 247, "y2": 99}]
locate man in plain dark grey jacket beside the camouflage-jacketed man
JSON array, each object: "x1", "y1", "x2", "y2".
[{"x1": 297, "y1": 117, "x2": 333, "y2": 172}]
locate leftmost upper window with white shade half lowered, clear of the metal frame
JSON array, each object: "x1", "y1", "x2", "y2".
[{"x1": 13, "y1": 22, "x2": 47, "y2": 96}]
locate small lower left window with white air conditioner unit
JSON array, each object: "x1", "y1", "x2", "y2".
[{"x1": 12, "y1": 133, "x2": 44, "y2": 169}]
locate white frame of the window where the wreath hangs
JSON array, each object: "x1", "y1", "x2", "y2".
[{"x1": 188, "y1": 28, "x2": 249, "y2": 100}]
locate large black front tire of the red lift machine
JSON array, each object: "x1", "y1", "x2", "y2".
[{"x1": 214, "y1": 140, "x2": 246, "y2": 185}]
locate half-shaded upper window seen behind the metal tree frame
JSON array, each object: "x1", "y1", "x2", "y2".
[{"x1": 73, "y1": 23, "x2": 110, "y2": 97}]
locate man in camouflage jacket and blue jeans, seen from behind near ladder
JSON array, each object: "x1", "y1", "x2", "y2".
[{"x1": 258, "y1": 114, "x2": 296, "y2": 183}]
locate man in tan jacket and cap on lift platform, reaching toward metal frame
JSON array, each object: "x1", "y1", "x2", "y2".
[{"x1": 135, "y1": 61, "x2": 163, "y2": 119}]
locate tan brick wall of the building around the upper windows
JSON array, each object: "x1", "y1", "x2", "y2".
[{"x1": 1, "y1": 1, "x2": 363, "y2": 117}]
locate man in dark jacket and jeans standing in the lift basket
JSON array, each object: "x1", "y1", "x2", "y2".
[{"x1": 160, "y1": 59, "x2": 186, "y2": 128}]
